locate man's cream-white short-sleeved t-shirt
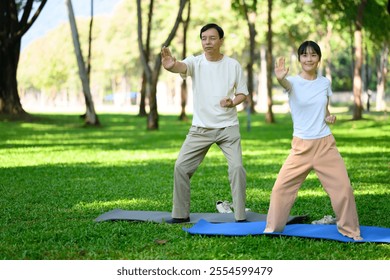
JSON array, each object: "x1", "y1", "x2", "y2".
[{"x1": 183, "y1": 54, "x2": 248, "y2": 128}]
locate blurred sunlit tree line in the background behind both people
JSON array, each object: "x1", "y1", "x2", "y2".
[{"x1": 0, "y1": 0, "x2": 390, "y2": 129}]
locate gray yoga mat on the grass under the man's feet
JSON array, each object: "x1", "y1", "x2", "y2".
[{"x1": 95, "y1": 209, "x2": 307, "y2": 224}]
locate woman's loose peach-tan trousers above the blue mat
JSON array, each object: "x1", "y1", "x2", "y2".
[{"x1": 264, "y1": 135, "x2": 360, "y2": 238}]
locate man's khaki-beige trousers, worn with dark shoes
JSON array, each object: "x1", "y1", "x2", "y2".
[{"x1": 172, "y1": 125, "x2": 246, "y2": 220}]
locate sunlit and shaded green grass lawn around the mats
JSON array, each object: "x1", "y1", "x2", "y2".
[{"x1": 0, "y1": 111, "x2": 390, "y2": 260}]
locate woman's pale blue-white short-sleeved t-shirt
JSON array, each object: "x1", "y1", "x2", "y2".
[{"x1": 287, "y1": 75, "x2": 332, "y2": 139}]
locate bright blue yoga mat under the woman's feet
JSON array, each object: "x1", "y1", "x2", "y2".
[{"x1": 183, "y1": 220, "x2": 390, "y2": 243}]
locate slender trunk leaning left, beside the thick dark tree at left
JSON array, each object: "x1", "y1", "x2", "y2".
[{"x1": 65, "y1": 0, "x2": 100, "y2": 125}]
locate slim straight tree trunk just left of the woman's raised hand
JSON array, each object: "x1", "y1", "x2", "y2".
[{"x1": 265, "y1": 0, "x2": 275, "y2": 123}]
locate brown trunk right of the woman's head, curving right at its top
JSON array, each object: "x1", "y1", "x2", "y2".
[{"x1": 353, "y1": 0, "x2": 367, "y2": 120}]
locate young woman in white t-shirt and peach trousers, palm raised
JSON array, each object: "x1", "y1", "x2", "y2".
[{"x1": 264, "y1": 41, "x2": 362, "y2": 240}]
